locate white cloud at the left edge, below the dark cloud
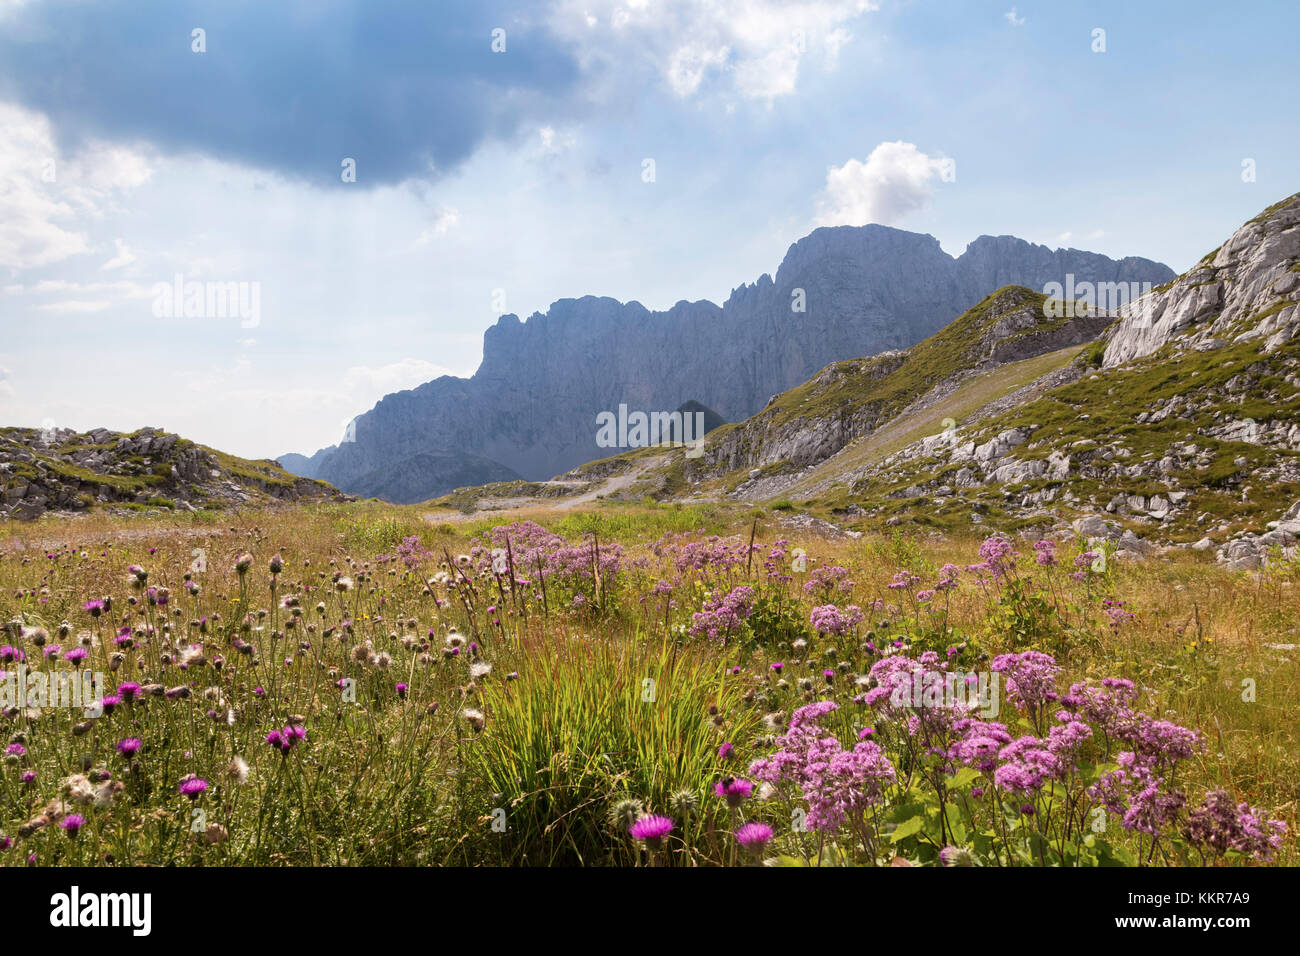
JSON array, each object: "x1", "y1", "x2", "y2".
[{"x1": 0, "y1": 103, "x2": 152, "y2": 269}]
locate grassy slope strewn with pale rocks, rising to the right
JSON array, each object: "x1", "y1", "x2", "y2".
[{"x1": 478, "y1": 194, "x2": 1300, "y2": 568}]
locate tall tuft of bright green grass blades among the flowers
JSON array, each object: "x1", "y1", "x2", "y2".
[{"x1": 471, "y1": 635, "x2": 758, "y2": 866}]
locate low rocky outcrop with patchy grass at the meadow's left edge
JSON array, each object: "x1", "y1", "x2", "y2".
[{"x1": 0, "y1": 428, "x2": 347, "y2": 520}]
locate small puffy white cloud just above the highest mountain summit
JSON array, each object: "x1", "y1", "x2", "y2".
[{"x1": 816, "y1": 142, "x2": 949, "y2": 226}]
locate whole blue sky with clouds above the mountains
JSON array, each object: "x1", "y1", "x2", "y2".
[{"x1": 0, "y1": 0, "x2": 1300, "y2": 457}]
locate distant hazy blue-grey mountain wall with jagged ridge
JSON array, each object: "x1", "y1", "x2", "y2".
[{"x1": 281, "y1": 225, "x2": 1174, "y2": 501}]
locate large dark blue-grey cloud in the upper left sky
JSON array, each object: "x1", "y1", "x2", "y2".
[{"x1": 0, "y1": 0, "x2": 579, "y2": 185}]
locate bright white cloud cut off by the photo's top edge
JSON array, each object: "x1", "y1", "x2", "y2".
[{"x1": 553, "y1": 0, "x2": 879, "y2": 103}]
